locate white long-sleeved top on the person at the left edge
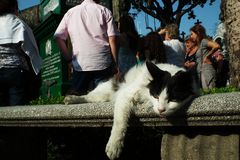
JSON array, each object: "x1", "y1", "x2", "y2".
[{"x1": 0, "y1": 14, "x2": 42, "y2": 74}]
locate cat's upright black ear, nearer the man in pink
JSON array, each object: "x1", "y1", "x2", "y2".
[{"x1": 146, "y1": 61, "x2": 171, "y2": 79}]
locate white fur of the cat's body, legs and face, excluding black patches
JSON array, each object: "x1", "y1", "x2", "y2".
[{"x1": 64, "y1": 64, "x2": 199, "y2": 159}]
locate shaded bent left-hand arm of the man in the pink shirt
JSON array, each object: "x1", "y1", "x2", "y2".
[{"x1": 55, "y1": 37, "x2": 72, "y2": 63}]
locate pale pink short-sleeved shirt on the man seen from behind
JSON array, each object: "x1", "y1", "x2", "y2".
[{"x1": 54, "y1": 0, "x2": 119, "y2": 71}]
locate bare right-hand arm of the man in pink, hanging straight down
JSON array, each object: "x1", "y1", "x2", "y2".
[{"x1": 108, "y1": 36, "x2": 118, "y2": 65}]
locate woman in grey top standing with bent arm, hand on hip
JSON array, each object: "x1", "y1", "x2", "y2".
[{"x1": 190, "y1": 24, "x2": 220, "y2": 89}]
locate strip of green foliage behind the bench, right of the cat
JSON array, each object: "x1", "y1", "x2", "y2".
[{"x1": 202, "y1": 86, "x2": 240, "y2": 95}]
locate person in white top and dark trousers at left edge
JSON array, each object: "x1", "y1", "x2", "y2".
[{"x1": 0, "y1": 0, "x2": 42, "y2": 106}]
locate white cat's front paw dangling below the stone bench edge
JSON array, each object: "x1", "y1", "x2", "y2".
[{"x1": 105, "y1": 136, "x2": 123, "y2": 160}]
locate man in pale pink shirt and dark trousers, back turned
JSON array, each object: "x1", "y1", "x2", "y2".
[{"x1": 54, "y1": 0, "x2": 119, "y2": 94}]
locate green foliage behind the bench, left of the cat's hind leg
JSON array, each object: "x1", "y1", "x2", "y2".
[{"x1": 30, "y1": 96, "x2": 64, "y2": 105}]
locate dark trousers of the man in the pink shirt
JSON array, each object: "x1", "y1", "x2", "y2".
[{"x1": 67, "y1": 66, "x2": 113, "y2": 95}]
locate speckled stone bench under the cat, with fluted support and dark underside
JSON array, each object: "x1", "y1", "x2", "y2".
[{"x1": 0, "y1": 92, "x2": 240, "y2": 160}]
